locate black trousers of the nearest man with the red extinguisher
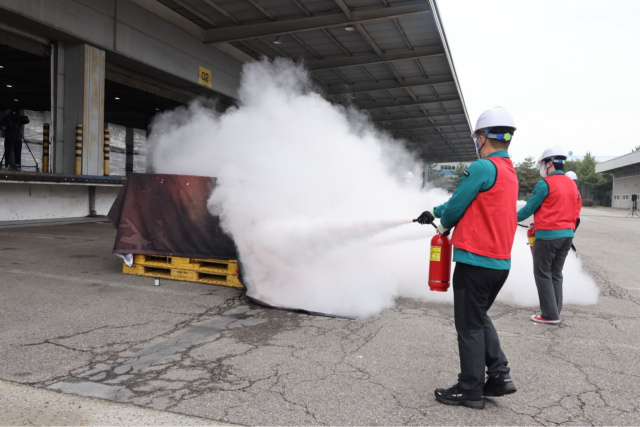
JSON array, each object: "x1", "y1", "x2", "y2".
[{"x1": 453, "y1": 262, "x2": 509, "y2": 397}]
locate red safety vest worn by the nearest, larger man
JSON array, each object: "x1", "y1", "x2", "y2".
[{"x1": 451, "y1": 157, "x2": 518, "y2": 259}]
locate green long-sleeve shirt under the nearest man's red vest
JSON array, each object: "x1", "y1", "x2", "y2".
[{"x1": 433, "y1": 150, "x2": 511, "y2": 270}]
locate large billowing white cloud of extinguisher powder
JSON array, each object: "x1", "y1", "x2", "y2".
[{"x1": 150, "y1": 60, "x2": 597, "y2": 315}]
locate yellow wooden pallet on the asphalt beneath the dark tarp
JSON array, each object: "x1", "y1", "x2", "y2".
[{"x1": 122, "y1": 255, "x2": 244, "y2": 288}]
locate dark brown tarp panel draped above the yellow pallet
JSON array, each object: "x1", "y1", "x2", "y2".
[{"x1": 107, "y1": 173, "x2": 237, "y2": 259}]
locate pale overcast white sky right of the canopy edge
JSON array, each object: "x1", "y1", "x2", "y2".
[{"x1": 437, "y1": 0, "x2": 640, "y2": 161}]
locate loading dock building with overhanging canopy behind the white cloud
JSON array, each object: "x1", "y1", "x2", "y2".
[{"x1": 0, "y1": 0, "x2": 475, "y2": 221}]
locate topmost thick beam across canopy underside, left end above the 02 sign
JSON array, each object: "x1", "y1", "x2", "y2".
[{"x1": 204, "y1": 0, "x2": 431, "y2": 43}]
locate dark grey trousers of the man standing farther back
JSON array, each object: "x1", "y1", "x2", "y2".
[{"x1": 533, "y1": 237, "x2": 573, "y2": 320}]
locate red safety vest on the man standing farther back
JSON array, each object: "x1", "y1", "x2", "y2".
[{"x1": 533, "y1": 173, "x2": 580, "y2": 230}]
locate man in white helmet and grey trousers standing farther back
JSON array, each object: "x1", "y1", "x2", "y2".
[{"x1": 518, "y1": 147, "x2": 581, "y2": 324}]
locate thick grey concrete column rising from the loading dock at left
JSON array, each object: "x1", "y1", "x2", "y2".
[{"x1": 56, "y1": 43, "x2": 105, "y2": 175}]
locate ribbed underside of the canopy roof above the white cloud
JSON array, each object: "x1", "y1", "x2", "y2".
[{"x1": 146, "y1": 0, "x2": 476, "y2": 161}]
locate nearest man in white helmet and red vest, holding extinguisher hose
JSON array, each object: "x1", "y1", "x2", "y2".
[{"x1": 418, "y1": 107, "x2": 518, "y2": 409}]
